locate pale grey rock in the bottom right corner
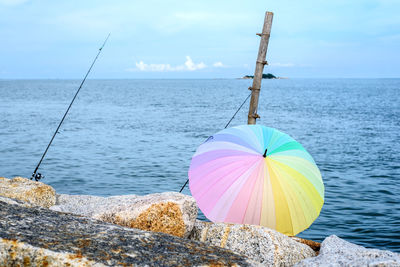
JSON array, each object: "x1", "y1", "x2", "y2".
[{"x1": 295, "y1": 235, "x2": 400, "y2": 267}]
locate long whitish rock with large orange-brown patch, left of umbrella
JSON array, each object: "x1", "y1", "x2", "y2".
[{"x1": 51, "y1": 192, "x2": 197, "y2": 237}]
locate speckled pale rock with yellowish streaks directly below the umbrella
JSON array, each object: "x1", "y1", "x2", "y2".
[{"x1": 189, "y1": 221, "x2": 316, "y2": 266}]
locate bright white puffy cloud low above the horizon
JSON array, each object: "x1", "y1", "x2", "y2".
[{"x1": 127, "y1": 56, "x2": 207, "y2": 72}]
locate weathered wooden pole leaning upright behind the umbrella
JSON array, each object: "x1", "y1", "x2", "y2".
[{"x1": 247, "y1": 11, "x2": 274, "y2": 124}]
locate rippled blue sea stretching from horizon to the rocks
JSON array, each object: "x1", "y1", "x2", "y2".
[{"x1": 0, "y1": 79, "x2": 400, "y2": 252}]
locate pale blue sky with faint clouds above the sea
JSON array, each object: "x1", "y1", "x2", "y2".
[{"x1": 0, "y1": 0, "x2": 400, "y2": 79}]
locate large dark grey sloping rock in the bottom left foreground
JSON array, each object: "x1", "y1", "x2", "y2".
[{"x1": 0, "y1": 200, "x2": 258, "y2": 266}]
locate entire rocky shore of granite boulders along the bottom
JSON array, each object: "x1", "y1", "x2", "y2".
[{"x1": 0, "y1": 177, "x2": 400, "y2": 266}]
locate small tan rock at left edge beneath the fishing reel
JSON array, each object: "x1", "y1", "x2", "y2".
[{"x1": 0, "y1": 177, "x2": 56, "y2": 208}]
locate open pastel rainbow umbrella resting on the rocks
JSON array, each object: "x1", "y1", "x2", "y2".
[{"x1": 189, "y1": 125, "x2": 324, "y2": 235}]
